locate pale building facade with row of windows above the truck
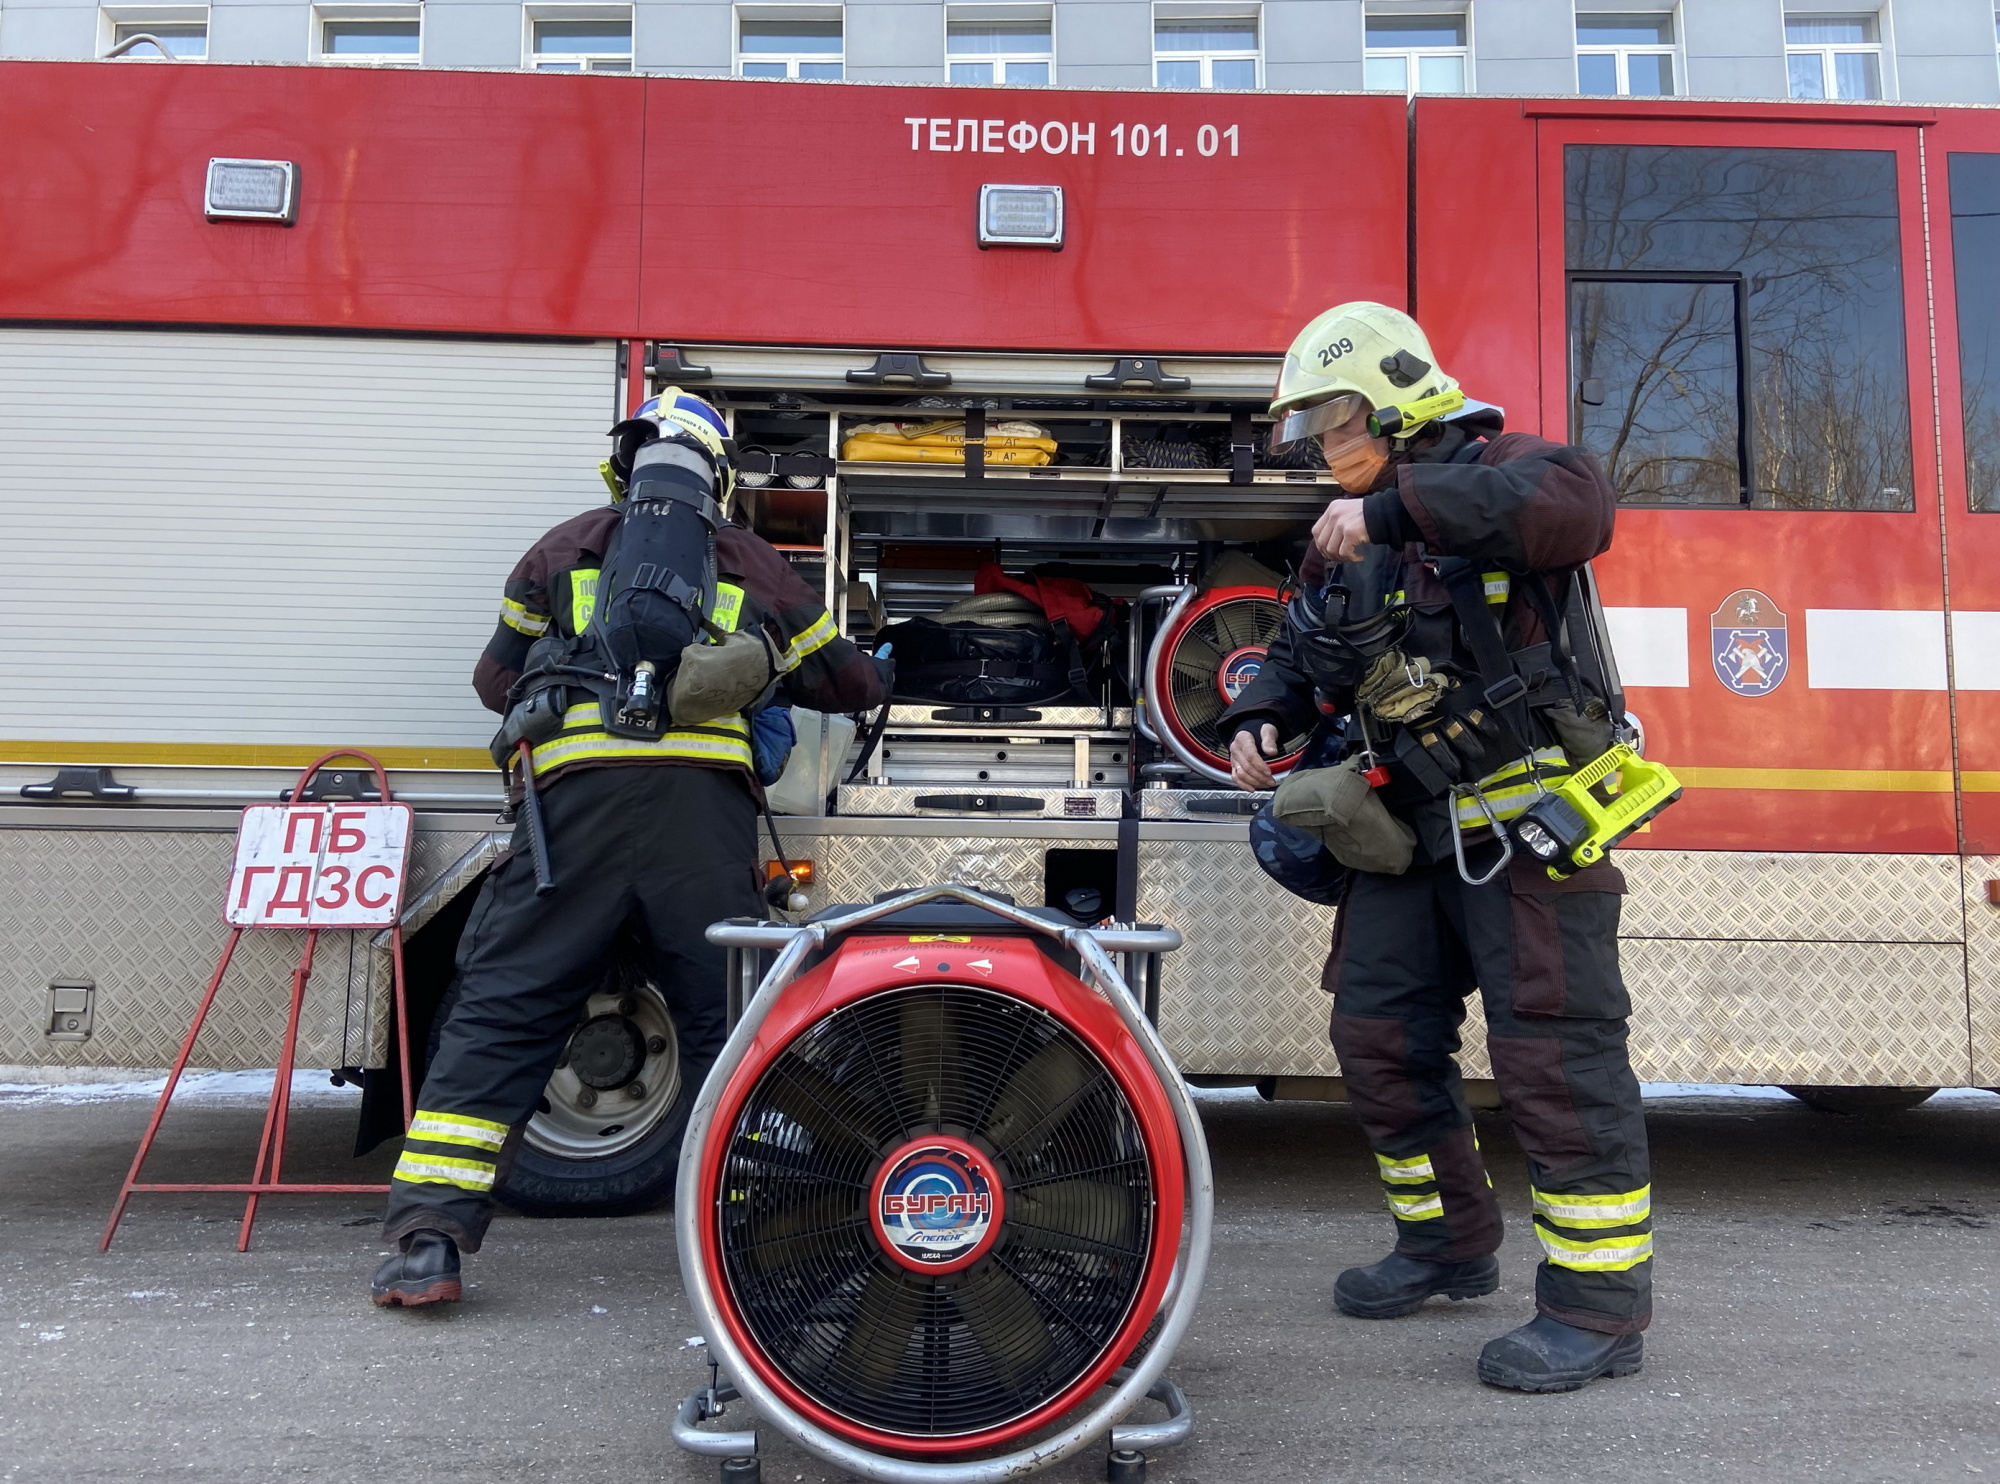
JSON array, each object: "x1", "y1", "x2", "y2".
[{"x1": 0, "y1": 0, "x2": 2000, "y2": 104}]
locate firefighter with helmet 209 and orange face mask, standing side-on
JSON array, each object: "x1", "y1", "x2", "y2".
[{"x1": 1224, "y1": 304, "x2": 1652, "y2": 1392}]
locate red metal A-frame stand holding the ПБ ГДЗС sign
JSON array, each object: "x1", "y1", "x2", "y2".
[{"x1": 98, "y1": 748, "x2": 414, "y2": 1252}]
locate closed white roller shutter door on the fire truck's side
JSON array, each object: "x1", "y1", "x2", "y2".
[{"x1": 0, "y1": 330, "x2": 616, "y2": 766}]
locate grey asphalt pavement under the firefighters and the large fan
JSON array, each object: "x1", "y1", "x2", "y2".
[{"x1": 0, "y1": 1084, "x2": 2000, "y2": 1484}]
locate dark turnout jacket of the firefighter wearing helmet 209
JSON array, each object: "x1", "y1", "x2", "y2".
[{"x1": 1222, "y1": 424, "x2": 1618, "y2": 858}]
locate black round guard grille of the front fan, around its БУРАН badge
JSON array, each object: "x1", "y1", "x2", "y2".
[{"x1": 716, "y1": 984, "x2": 1154, "y2": 1438}]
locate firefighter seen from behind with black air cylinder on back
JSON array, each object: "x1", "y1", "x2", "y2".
[{"x1": 372, "y1": 390, "x2": 888, "y2": 1306}]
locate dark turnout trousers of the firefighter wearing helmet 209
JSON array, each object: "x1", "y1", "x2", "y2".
[{"x1": 1326, "y1": 858, "x2": 1652, "y2": 1334}]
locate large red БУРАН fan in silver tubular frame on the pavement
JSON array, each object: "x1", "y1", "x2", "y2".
[{"x1": 674, "y1": 888, "x2": 1210, "y2": 1484}]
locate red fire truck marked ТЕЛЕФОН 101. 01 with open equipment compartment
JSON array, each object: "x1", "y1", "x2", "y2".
[{"x1": 0, "y1": 62, "x2": 2000, "y2": 1206}]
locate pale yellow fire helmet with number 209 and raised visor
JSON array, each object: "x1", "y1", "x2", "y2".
[{"x1": 1270, "y1": 300, "x2": 1466, "y2": 454}]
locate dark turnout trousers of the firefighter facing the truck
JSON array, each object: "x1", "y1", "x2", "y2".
[{"x1": 384, "y1": 764, "x2": 762, "y2": 1252}]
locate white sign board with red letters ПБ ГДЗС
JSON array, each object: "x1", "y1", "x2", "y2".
[{"x1": 222, "y1": 804, "x2": 412, "y2": 928}]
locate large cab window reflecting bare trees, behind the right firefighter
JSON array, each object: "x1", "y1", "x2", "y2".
[{"x1": 1566, "y1": 144, "x2": 1916, "y2": 510}]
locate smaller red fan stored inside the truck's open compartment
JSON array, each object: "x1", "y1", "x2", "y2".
[{"x1": 1146, "y1": 588, "x2": 1308, "y2": 784}]
